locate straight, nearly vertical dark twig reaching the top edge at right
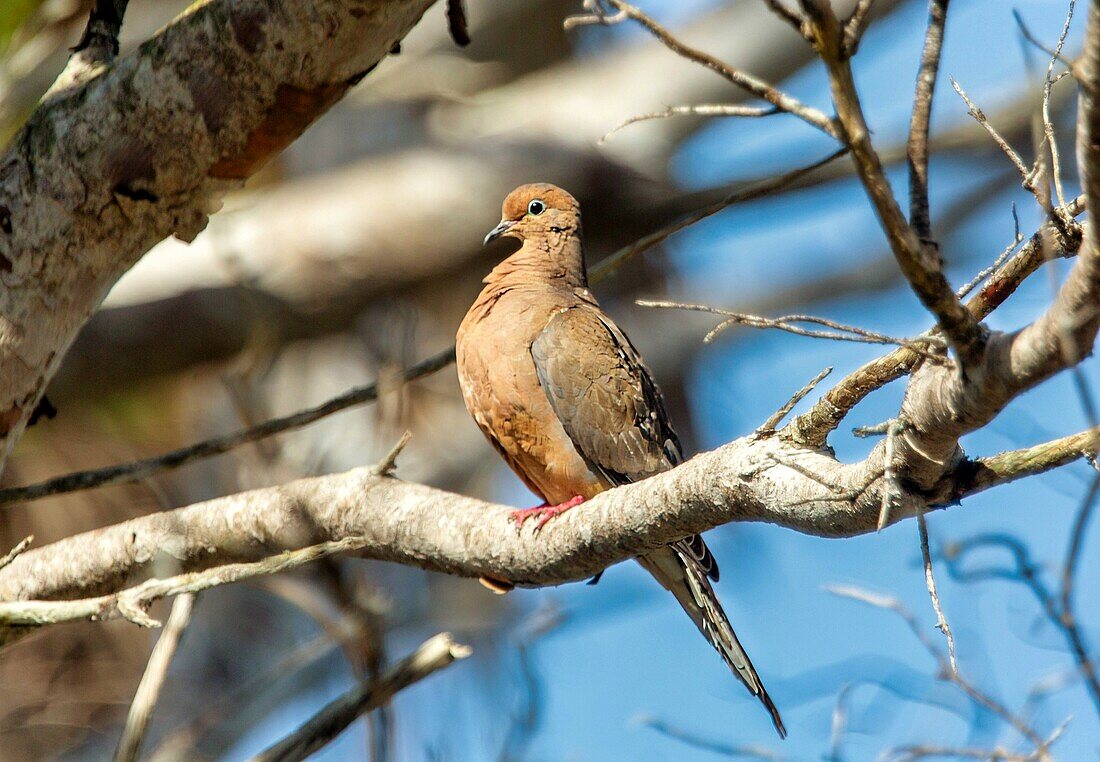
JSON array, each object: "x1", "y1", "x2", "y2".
[{"x1": 906, "y1": 0, "x2": 949, "y2": 241}]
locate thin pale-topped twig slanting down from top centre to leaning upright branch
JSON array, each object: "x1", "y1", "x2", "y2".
[{"x1": 565, "y1": 0, "x2": 839, "y2": 137}]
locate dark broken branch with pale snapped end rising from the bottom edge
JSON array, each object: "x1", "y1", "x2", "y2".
[{"x1": 251, "y1": 632, "x2": 471, "y2": 762}]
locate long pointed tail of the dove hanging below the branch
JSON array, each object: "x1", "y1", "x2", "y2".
[{"x1": 638, "y1": 537, "x2": 787, "y2": 738}]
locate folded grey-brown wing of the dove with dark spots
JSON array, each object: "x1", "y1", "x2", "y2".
[{"x1": 531, "y1": 303, "x2": 683, "y2": 485}]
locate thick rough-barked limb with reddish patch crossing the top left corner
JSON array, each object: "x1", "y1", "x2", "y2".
[{"x1": 0, "y1": 0, "x2": 431, "y2": 464}]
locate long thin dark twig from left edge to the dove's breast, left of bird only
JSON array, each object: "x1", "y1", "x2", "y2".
[{"x1": 0, "y1": 346, "x2": 454, "y2": 506}]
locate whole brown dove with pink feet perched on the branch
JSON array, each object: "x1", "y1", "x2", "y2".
[{"x1": 455, "y1": 183, "x2": 787, "y2": 738}]
